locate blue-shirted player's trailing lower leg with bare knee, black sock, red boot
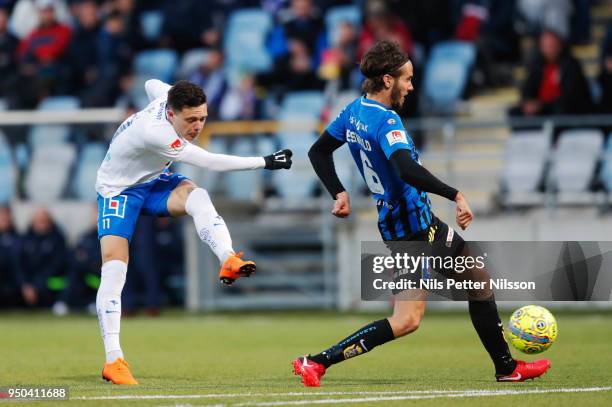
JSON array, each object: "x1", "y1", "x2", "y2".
[{"x1": 292, "y1": 301, "x2": 426, "y2": 387}]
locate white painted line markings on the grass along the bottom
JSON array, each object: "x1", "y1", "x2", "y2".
[{"x1": 70, "y1": 386, "x2": 612, "y2": 406}]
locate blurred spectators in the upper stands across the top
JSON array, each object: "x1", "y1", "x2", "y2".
[{"x1": 0, "y1": 0, "x2": 612, "y2": 120}]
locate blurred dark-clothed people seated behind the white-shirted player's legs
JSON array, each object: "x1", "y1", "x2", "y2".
[{"x1": 0, "y1": 206, "x2": 184, "y2": 316}]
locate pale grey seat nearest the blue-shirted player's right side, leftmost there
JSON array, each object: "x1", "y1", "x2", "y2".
[{"x1": 502, "y1": 131, "x2": 551, "y2": 193}]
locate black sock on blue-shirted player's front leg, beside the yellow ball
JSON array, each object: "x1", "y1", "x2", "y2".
[{"x1": 469, "y1": 296, "x2": 516, "y2": 375}]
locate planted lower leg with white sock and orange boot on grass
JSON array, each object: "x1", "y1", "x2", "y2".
[{"x1": 96, "y1": 260, "x2": 138, "y2": 384}]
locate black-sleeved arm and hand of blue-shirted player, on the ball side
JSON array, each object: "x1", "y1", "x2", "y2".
[{"x1": 389, "y1": 149, "x2": 474, "y2": 229}]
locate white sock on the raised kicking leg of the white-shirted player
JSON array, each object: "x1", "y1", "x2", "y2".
[{"x1": 185, "y1": 188, "x2": 234, "y2": 264}]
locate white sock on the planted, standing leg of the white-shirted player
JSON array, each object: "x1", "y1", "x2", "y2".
[{"x1": 96, "y1": 260, "x2": 127, "y2": 363}]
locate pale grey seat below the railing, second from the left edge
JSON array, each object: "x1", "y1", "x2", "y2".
[{"x1": 25, "y1": 143, "x2": 76, "y2": 202}]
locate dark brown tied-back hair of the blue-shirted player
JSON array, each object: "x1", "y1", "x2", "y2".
[{"x1": 359, "y1": 40, "x2": 410, "y2": 93}]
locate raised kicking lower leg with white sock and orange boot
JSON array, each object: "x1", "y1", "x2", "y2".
[{"x1": 185, "y1": 188, "x2": 256, "y2": 285}]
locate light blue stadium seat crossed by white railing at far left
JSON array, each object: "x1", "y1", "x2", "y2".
[{"x1": 28, "y1": 96, "x2": 80, "y2": 146}]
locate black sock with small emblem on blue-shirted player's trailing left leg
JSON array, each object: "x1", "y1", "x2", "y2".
[{"x1": 308, "y1": 319, "x2": 395, "y2": 368}]
